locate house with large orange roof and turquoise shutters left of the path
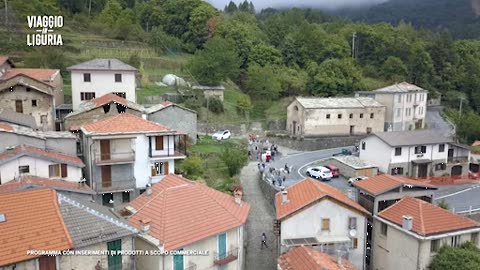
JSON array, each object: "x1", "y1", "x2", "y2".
[{"x1": 125, "y1": 174, "x2": 250, "y2": 270}]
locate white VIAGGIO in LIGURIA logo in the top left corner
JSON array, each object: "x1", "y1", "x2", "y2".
[{"x1": 27, "y1": 16, "x2": 63, "y2": 46}]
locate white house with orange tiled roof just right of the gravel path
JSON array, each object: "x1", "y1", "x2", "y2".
[{"x1": 275, "y1": 178, "x2": 369, "y2": 269}]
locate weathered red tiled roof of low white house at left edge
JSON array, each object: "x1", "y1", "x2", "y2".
[{"x1": 0, "y1": 145, "x2": 85, "y2": 167}]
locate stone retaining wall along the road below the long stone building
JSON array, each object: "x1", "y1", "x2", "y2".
[{"x1": 267, "y1": 135, "x2": 366, "y2": 151}]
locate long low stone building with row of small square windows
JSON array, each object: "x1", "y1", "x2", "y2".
[{"x1": 287, "y1": 97, "x2": 385, "y2": 136}]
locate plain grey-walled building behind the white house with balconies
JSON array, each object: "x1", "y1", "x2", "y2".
[{"x1": 145, "y1": 101, "x2": 197, "y2": 143}]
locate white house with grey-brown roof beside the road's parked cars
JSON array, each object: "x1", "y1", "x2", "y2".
[{"x1": 359, "y1": 130, "x2": 470, "y2": 178}]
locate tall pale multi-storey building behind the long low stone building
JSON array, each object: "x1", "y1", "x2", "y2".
[{"x1": 356, "y1": 82, "x2": 428, "y2": 131}]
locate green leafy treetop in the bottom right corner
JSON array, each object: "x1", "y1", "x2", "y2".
[{"x1": 430, "y1": 242, "x2": 480, "y2": 270}]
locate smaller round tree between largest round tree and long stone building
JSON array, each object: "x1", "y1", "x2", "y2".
[{"x1": 246, "y1": 64, "x2": 282, "y2": 100}]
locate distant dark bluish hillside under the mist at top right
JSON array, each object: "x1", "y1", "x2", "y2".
[{"x1": 336, "y1": 0, "x2": 480, "y2": 38}]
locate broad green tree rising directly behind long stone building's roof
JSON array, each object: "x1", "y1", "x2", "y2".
[{"x1": 307, "y1": 59, "x2": 364, "y2": 97}]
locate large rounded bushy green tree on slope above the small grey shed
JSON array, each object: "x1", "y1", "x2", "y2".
[{"x1": 188, "y1": 37, "x2": 240, "y2": 85}]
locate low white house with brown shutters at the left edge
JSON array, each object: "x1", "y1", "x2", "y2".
[{"x1": 0, "y1": 145, "x2": 85, "y2": 184}]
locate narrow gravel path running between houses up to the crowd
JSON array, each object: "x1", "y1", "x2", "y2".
[{"x1": 240, "y1": 162, "x2": 277, "y2": 270}]
